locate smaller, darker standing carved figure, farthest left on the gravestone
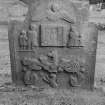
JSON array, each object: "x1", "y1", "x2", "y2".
[{"x1": 19, "y1": 30, "x2": 28, "y2": 50}]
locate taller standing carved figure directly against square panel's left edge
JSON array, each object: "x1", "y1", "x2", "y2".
[{"x1": 29, "y1": 24, "x2": 38, "y2": 48}]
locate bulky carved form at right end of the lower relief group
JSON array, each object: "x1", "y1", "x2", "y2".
[{"x1": 59, "y1": 57, "x2": 86, "y2": 87}]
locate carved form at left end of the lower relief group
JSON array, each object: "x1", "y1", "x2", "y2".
[{"x1": 21, "y1": 58, "x2": 41, "y2": 85}]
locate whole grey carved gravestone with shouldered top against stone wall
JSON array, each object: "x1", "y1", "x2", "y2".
[{"x1": 9, "y1": 0, "x2": 98, "y2": 90}]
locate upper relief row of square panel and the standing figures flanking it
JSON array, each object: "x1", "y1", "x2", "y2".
[{"x1": 18, "y1": 24, "x2": 81, "y2": 50}]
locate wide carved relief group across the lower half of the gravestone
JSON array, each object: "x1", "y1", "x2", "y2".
[{"x1": 21, "y1": 52, "x2": 85, "y2": 88}]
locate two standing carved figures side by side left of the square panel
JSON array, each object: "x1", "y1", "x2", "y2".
[{"x1": 18, "y1": 24, "x2": 38, "y2": 50}]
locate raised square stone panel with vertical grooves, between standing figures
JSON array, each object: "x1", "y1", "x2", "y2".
[{"x1": 41, "y1": 24, "x2": 67, "y2": 46}]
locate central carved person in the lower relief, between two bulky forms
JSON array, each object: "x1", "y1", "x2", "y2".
[{"x1": 40, "y1": 51, "x2": 57, "y2": 87}]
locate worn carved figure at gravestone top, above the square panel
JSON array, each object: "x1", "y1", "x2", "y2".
[{"x1": 47, "y1": 0, "x2": 75, "y2": 23}]
